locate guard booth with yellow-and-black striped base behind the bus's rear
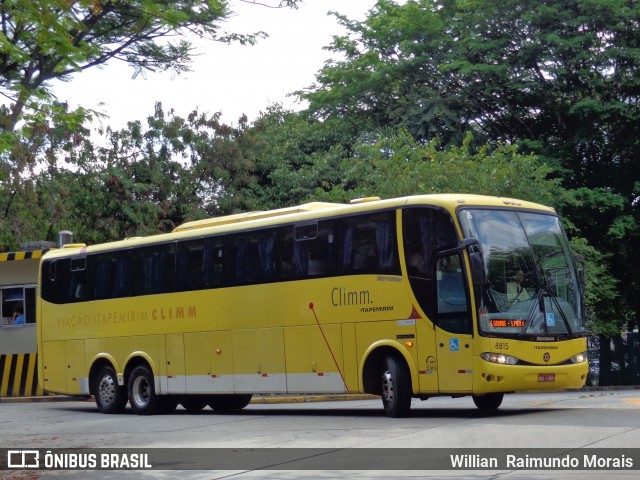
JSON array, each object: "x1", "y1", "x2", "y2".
[{"x1": 0, "y1": 242, "x2": 55, "y2": 397}]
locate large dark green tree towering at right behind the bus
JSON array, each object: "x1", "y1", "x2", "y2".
[{"x1": 300, "y1": 0, "x2": 640, "y2": 334}]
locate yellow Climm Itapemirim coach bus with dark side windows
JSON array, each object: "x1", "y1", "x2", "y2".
[{"x1": 38, "y1": 194, "x2": 588, "y2": 417}]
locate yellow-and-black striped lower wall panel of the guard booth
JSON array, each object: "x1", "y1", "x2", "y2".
[{"x1": 0, "y1": 353, "x2": 43, "y2": 397}]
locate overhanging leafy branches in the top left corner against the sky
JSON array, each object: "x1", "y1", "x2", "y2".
[{"x1": 0, "y1": 0, "x2": 242, "y2": 132}]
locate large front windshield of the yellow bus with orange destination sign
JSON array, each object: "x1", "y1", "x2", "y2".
[{"x1": 460, "y1": 209, "x2": 586, "y2": 339}]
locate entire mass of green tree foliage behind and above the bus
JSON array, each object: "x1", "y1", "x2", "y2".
[{"x1": 0, "y1": 0, "x2": 640, "y2": 335}]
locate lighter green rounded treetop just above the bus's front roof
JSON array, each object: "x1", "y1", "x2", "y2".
[{"x1": 316, "y1": 130, "x2": 570, "y2": 206}]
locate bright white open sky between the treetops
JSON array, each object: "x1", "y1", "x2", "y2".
[{"x1": 53, "y1": 0, "x2": 376, "y2": 129}]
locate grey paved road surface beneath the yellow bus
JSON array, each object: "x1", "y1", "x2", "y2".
[{"x1": 0, "y1": 390, "x2": 640, "y2": 480}]
